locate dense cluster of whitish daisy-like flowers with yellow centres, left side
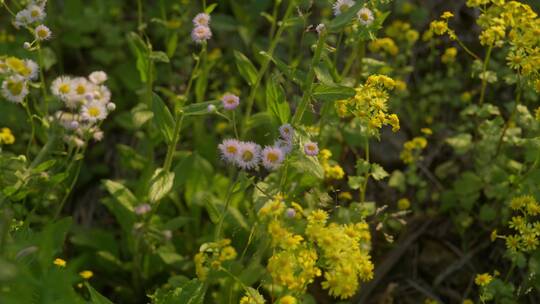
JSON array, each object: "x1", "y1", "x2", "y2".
[{"x1": 51, "y1": 71, "x2": 116, "y2": 146}]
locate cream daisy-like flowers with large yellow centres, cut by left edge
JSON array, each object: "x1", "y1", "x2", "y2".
[{"x1": 0, "y1": 57, "x2": 39, "y2": 103}]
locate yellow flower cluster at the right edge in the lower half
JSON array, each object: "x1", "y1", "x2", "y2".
[{"x1": 502, "y1": 195, "x2": 540, "y2": 252}]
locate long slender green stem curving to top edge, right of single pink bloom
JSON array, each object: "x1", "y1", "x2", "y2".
[{"x1": 242, "y1": 0, "x2": 294, "y2": 137}]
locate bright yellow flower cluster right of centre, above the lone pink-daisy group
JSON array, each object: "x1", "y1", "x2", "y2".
[{"x1": 336, "y1": 75, "x2": 399, "y2": 132}]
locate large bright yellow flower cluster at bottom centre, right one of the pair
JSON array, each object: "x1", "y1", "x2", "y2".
[{"x1": 306, "y1": 210, "x2": 374, "y2": 299}]
